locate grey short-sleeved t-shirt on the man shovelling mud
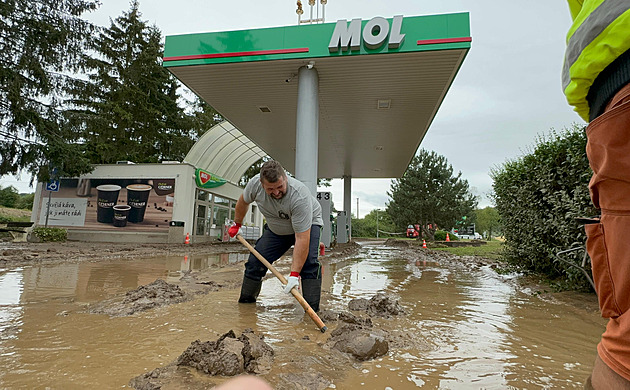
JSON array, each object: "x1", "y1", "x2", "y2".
[{"x1": 243, "y1": 174, "x2": 324, "y2": 235}]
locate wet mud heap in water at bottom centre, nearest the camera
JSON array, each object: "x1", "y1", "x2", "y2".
[{"x1": 176, "y1": 329, "x2": 274, "y2": 376}]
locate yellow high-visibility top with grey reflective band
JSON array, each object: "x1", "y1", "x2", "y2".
[{"x1": 562, "y1": 0, "x2": 630, "y2": 122}]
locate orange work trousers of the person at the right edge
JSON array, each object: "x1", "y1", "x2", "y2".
[{"x1": 585, "y1": 84, "x2": 630, "y2": 385}]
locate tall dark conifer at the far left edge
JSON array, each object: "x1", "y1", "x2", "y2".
[{"x1": 0, "y1": 0, "x2": 99, "y2": 181}]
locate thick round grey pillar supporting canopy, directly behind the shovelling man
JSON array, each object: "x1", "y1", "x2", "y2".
[{"x1": 295, "y1": 63, "x2": 319, "y2": 196}]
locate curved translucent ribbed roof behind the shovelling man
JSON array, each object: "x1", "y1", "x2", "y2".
[{"x1": 184, "y1": 121, "x2": 266, "y2": 183}]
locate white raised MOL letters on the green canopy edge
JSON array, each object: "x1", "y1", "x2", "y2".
[{"x1": 328, "y1": 15, "x2": 405, "y2": 53}]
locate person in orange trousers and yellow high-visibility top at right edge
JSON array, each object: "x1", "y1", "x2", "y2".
[{"x1": 562, "y1": 0, "x2": 630, "y2": 389}]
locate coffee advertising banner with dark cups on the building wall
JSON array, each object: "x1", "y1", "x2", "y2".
[{"x1": 39, "y1": 178, "x2": 175, "y2": 231}]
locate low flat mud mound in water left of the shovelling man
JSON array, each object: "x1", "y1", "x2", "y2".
[{"x1": 88, "y1": 279, "x2": 190, "y2": 317}]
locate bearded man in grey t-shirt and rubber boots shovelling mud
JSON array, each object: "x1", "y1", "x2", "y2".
[{"x1": 228, "y1": 160, "x2": 324, "y2": 311}]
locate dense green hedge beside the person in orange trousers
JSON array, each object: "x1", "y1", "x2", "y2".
[{"x1": 491, "y1": 125, "x2": 597, "y2": 289}]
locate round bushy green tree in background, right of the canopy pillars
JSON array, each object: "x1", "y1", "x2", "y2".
[{"x1": 387, "y1": 149, "x2": 477, "y2": 240}]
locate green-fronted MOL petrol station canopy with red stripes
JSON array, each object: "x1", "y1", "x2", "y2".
[{"x1": 164, "y1": 13, "x2": 471, "y2": 179}]
